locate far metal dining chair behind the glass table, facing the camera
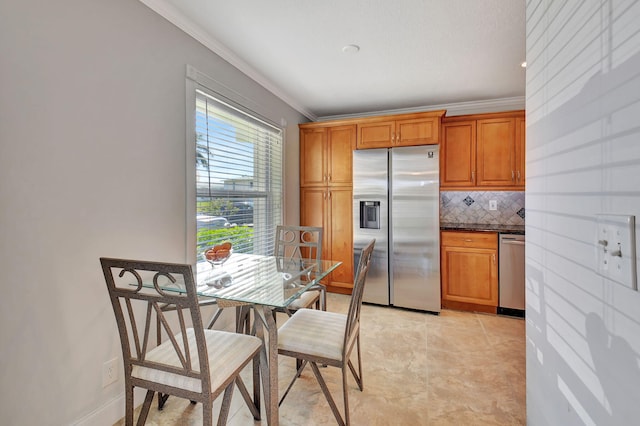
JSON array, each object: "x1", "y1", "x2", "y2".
[{"x1": 274, "y1": 225, "x2": 327, "y2": 316}]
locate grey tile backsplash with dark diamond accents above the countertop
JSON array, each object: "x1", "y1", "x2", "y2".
[{"x1": 440, "y1": 191, "x2": 524, "y2": 225}]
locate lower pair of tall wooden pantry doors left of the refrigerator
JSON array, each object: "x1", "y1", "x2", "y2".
[{"x1": 300, "y1": 187, "x2": 353, "y2": 294}]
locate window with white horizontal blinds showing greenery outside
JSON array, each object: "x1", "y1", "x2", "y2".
[{"x1": 191, "y1": 89, "x2": 283, "y2": 262}]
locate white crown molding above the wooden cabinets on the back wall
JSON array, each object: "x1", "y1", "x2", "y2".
[{"x1": 317, "y1": 96, "x2": 526, "y2": 121}]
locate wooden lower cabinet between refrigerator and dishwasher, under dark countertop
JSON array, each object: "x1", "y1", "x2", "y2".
[{"x1": 440, "y1": 231, "x2": 498, "y2": 313}]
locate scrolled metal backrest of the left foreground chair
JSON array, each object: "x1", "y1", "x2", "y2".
[{"x1": 100, "y1": 258, "x2": 211, "y2": 390}]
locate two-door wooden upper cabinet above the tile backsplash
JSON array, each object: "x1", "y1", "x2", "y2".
[{"x1": 440, "y1": 111, "x2": 525, "y2": 190}]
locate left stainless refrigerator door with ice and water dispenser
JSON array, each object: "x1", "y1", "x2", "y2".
[{"x1": 353, "y1": 149, "x2": 389, "y2": 305}]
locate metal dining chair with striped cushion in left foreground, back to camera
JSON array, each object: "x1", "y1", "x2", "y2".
[{"x1": 100, "y1": 258, "x2": 262, "y2": 426}]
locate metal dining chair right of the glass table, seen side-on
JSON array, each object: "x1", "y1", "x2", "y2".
[{"x1": 278, "y1": 240, "x2": 375, "y2": 425}]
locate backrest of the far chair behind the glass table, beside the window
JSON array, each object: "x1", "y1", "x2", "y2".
[{"x1": 274, "y1": 225, "x2": 323, "y2": 260}]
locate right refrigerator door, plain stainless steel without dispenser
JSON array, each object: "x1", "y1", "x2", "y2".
[{"x1": 390, "y1": 145, "x2": 440, "y2": 312}]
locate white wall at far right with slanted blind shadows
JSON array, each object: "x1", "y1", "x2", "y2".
[{"x1": 526, "y1": 0, "x2": 640, "y2": 425}]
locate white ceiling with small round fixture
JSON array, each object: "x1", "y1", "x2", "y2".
[{"x1": 141, "y1": 0, "x2": 525, "y2": 120}]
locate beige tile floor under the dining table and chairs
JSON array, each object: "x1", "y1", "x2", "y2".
[{"x1": 116, "y1": 294, "x2": 526, "y2": 426}]
